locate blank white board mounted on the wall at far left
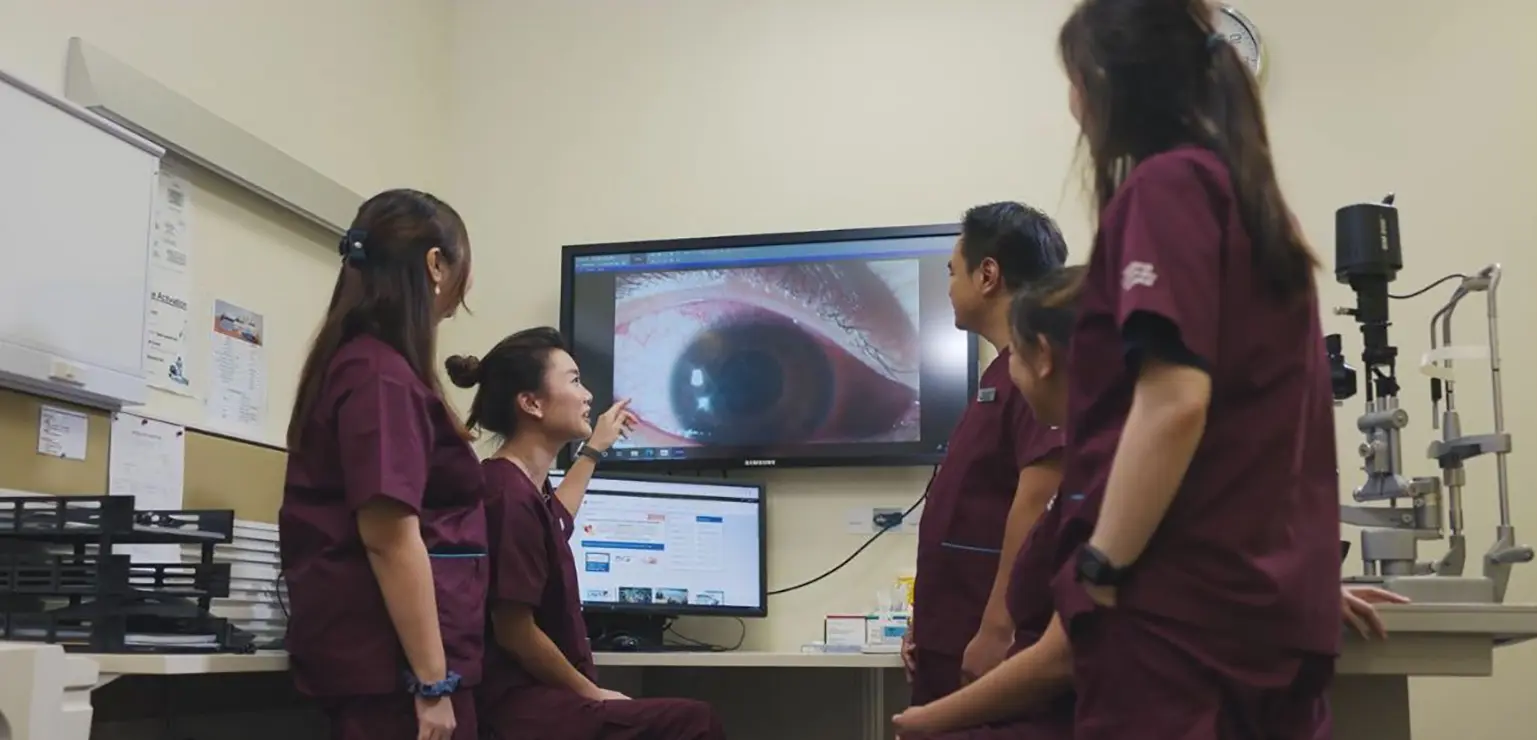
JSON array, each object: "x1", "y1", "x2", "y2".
[{"x1": 0, "y1": 66, "x2": 163, "y2": 408}]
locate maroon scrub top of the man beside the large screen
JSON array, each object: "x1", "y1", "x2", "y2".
[{"x1": 913, "y1": 349, "x2": 1063, "y2": 657}]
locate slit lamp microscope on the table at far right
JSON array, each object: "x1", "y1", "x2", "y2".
[{"x1": 1325, "y1": 195, "x2": 1532, "y2": 605}]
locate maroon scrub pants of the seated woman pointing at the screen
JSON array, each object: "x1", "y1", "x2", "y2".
[{"x1": 485, "y1": 686, "x2": 725, "y2": 740}]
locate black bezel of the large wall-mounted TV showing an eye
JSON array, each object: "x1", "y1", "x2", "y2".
[{"x1": 558, "y1": 223, "x2": 981, "y2": 472}]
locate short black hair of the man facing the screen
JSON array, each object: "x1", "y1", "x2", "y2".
[{"x1": 961, "y1": 202, "x2": 1067, "y2": 291}]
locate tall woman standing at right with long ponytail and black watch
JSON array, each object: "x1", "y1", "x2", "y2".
[{"x1": 1053, "y1": 0, "x2": 1340, "y2": 740}]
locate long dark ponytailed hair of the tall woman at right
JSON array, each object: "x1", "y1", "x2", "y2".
[{"x1": 1057, "y1": 0, "x2": 1319, "y2": 300}]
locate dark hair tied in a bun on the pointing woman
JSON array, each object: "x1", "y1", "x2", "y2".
[{"x1": 444, "y1": 326, "x2": 567, "y2": 438}]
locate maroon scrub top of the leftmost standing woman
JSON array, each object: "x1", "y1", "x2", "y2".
[{"x1": 278, "y1": 335, "x2": 490, "y2": 697}]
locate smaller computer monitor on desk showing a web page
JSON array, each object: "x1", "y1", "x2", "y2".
[{"x1": 550, "y1": 474, "x2": 769, "y2": 649}]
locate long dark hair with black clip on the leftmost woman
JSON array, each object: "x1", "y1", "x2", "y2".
[{"x1": 287, "y1": 189, "x2": 470, "y2": 449}]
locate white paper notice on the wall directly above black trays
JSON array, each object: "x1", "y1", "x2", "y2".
[{"x1": 106, "y1": 412, "x2": 186, "y2": 563}]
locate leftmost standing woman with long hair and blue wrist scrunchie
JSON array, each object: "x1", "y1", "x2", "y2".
[{"x1": 278, "y1": 191, "x2": 490, "y2": 740}]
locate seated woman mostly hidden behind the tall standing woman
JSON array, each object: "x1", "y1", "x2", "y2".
[{"x1": 893, "y1": 272, "x2": 1403, "y2": 740}]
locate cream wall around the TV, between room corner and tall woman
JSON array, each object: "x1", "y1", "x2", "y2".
[{"x1": 444, "y1": 0, "x2": 1088, "y2": 649}]
